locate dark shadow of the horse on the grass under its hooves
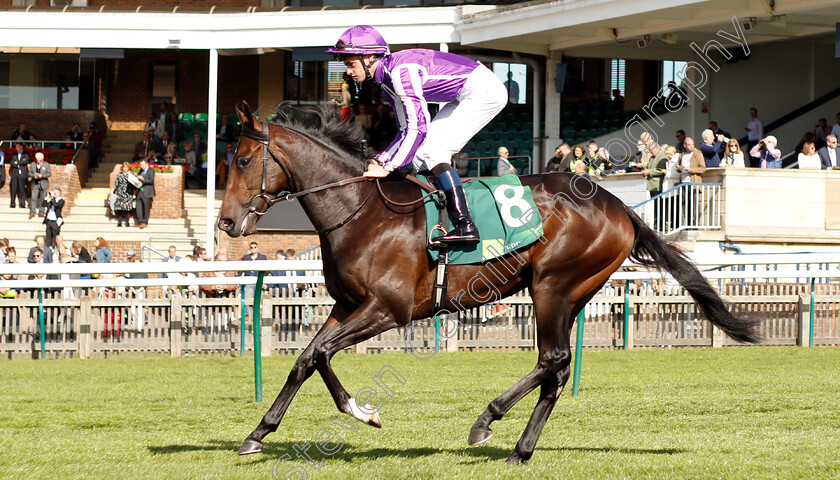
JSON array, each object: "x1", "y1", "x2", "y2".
[{"x1": 148, "y1": 440, "x2": 688, "y2": 464}]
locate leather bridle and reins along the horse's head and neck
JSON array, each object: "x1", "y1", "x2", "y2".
[{"x1": 242, "y1": 122, "x2": 441, "y2": 235}]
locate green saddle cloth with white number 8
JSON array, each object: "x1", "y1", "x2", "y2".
[{"x1": 418, "y1": 174, "x2": 543, "y2": 265}]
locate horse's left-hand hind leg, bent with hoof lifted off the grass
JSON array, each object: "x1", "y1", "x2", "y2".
[{"x1": 468, "y1": 296, "x2": 571, "y2": 445}]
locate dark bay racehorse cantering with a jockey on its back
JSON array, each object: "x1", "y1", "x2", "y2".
[{"x1": 218, "y1": 104, "x2": 760, "y2": 462}]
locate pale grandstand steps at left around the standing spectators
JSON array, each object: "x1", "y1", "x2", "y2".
[{"x1": 0, "y1": 131, "x2": 224, "y2": 262}]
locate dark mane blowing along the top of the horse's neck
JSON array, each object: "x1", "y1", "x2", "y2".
[{"x1": 258, "y1": 103, "x2": 368, "y2": 164}]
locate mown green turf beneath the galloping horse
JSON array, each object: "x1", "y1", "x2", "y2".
[{"x1": 0, "y1": 347, "x2": 840, "y2": 479}]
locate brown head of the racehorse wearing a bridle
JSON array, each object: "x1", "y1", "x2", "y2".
[{"x1": 218, "y1": 102, "x2": 291, "y2": 237}]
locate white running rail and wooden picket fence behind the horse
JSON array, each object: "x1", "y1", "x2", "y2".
[{"x1": 0, "y1": 255, "x2": 840, "y2": 358}]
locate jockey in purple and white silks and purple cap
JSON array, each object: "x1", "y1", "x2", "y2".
[{"x1": 327, "y1": 25, "x2": 508, "y2": 245}]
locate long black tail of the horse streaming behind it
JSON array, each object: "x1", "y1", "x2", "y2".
[{"x1": 625, "y1": 206, "x2": 762, "y2": 343}]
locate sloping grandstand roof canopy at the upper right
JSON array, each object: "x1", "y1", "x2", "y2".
[{"x1": 456, "y1": 0, "x2": 840, "y2": 59}]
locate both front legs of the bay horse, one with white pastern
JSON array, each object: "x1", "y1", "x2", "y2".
[{"x1": 239, "y1": 297, "x2": 406, "y2": 455}]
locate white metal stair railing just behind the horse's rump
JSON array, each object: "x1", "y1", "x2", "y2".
[{"x1": 633, "y1": 183, "x2": 722, "y2": 235}]
